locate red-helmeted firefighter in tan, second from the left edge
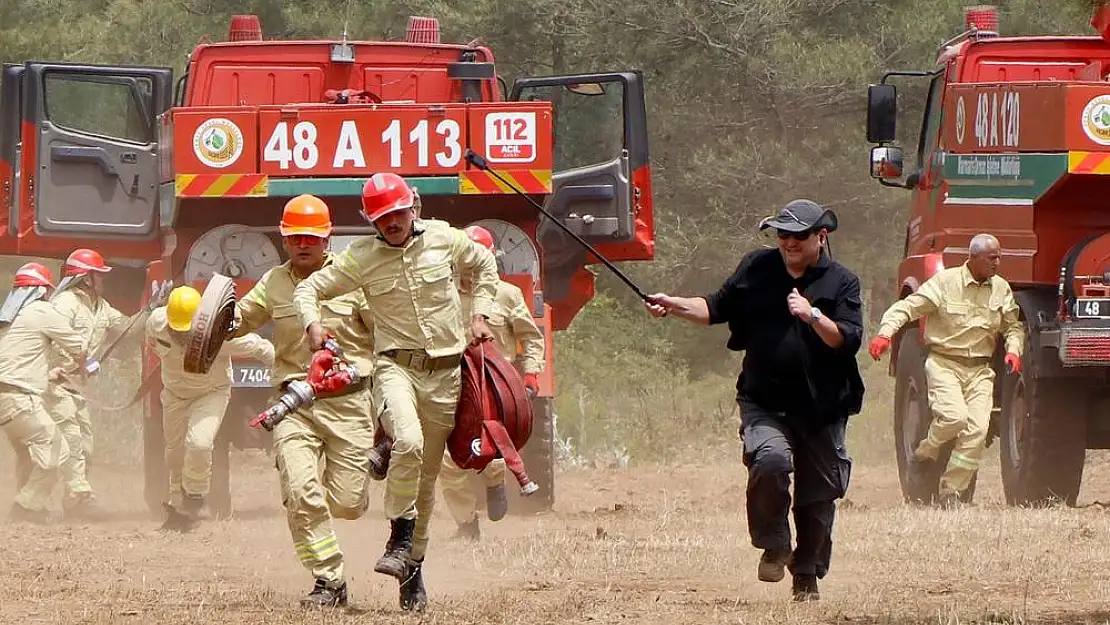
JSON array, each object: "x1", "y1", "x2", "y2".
[{"x1": 43, "y1": 249, "x2": 134, "y2": 518}]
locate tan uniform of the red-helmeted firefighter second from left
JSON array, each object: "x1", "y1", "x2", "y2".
[{"x1": 43, "y1": 286, "x2": 127, "y2": 501}]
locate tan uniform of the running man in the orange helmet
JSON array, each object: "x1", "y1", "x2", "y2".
[{"x1": 235, "y1": 253, "x2": 374, "y2": 584}]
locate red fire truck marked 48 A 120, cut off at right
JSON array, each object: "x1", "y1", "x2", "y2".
[{"x1": 867, "y1": 2, "x2": 1110, "y2": 505}]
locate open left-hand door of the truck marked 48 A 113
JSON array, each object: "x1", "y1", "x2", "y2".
[{"x1": 14, "y1": 62, "x2": 173, "y2": 259}]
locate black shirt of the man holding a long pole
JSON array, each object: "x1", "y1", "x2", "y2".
[{"x1": 705, "y1": 249, "x2": 864, "y2": 422}]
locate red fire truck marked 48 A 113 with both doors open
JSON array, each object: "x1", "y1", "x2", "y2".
[{"x1": 0, "y1": 16, "x2": 655, "y2": 519}]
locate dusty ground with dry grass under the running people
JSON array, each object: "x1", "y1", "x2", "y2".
[{"x1": 0, "y1": 437, "x2": 1110, "y2": 625}]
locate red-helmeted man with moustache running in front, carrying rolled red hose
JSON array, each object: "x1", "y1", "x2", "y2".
[{"x1": 293, "y1": 173, "x2": 497, "y2": 611}]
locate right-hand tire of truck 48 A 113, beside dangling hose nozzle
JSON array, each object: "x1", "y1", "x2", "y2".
[{"x1": 505, "y1": 397, "x2": 555, "y2": 515}]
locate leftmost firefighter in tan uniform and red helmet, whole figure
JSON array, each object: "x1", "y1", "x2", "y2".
[{"x1": 0, "y1": 263, "x2": 88, "y2": 523}]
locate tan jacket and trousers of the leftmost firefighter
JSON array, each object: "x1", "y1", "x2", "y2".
[{"x1": 0, "y1": 301, "x2": 89, "y2": 512}]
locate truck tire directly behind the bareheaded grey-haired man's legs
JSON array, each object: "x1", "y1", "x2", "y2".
[{"x1": 894, "y1": 333, "x2": 979, "y2": 504}]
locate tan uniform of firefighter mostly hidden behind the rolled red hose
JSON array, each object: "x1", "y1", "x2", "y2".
[{"x1": 440, "y1": 280, "x2": 544, "y2": 525}]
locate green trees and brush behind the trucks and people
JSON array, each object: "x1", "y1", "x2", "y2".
[{"x1": 0, "y1": 0, "x2": 1093, "y2": 466}]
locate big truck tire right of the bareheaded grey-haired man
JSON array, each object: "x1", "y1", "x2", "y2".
[{"x1": 999, "y1": 373, "x2": 1087, "y2": 506}]
